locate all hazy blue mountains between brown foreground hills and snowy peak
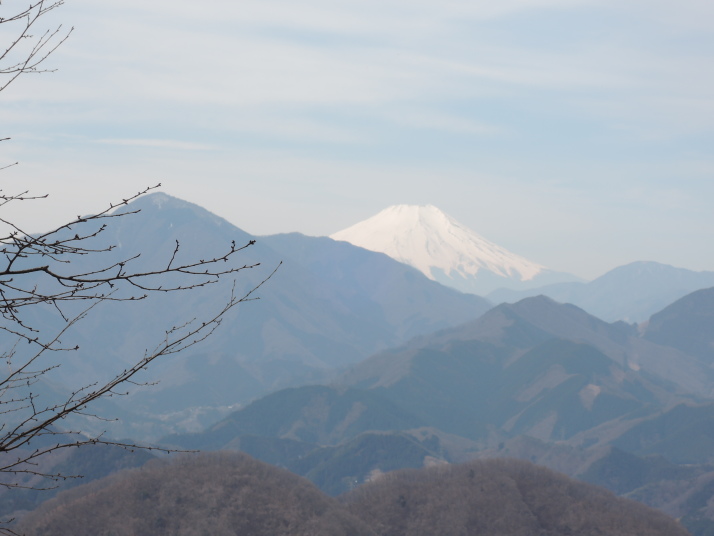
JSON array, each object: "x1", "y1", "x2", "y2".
[{"x1": 8, "y1": 194, "x2": 714, "y2": 536}]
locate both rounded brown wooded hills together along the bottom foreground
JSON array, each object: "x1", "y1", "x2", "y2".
[{"x1": 18, "y1": 452, "x2": 687, "y2": 536}]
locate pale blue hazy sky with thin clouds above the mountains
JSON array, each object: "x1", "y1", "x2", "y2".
[{"x1": 0, "y1": 0, "x2": 714, "y2": 278}]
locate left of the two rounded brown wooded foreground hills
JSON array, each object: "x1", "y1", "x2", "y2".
[{"x1": 19, "y1": 453, "x2": 373, "y2": 536}]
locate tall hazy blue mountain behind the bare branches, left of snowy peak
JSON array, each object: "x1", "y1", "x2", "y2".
[{"x1": 3, "y1": 193, "x2": 492, "y2": 439}]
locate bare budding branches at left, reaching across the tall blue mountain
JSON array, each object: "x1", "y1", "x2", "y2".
[{"x1": 0, "y1": 191, "x2": 277, "y2": 496}]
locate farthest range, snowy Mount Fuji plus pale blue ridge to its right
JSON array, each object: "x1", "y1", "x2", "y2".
[{"x1": 331, "y1": 205, "x2": 714, "y2": 323}]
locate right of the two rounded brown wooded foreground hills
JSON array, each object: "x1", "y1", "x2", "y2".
[{"x1": 344, "y1": 460, "x2": 687, "y2": 536}]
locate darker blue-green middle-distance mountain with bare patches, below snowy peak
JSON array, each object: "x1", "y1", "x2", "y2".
[{"x1": 171, "y1": 297, "x2": 714, "y2": 449}]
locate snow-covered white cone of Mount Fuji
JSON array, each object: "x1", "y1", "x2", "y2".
[{"x1": 330, "y1": 205, "x2": 579, "y2": 294}]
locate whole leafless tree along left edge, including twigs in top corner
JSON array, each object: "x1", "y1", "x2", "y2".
[{"x1": 0, "y1": 0, "x2": 272, "y2": 534}]
